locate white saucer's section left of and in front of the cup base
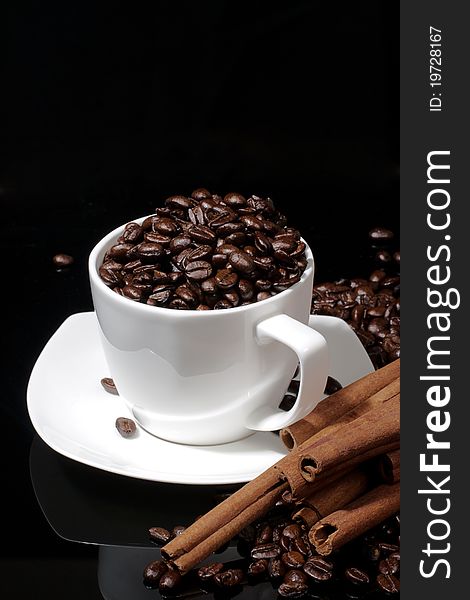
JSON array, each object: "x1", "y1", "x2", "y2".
[{"x1": 28, "y1": 312, "x2": 286, "y2": 484}]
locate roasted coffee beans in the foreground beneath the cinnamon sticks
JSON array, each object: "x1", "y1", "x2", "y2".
[{"x1": 143, "y1": 501, "x2": 400, "y2": 600}]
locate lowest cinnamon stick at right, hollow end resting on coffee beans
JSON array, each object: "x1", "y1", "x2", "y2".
[{"x1": 308, "y1": 483, "x2": 400, "y2": 555}]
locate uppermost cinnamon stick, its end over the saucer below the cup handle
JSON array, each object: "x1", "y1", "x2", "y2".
[{"x1": 280, "y1": 359, "x2": 400, "y2": 450}]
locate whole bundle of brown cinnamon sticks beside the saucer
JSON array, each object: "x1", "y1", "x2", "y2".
[{"x1": 162, "y1": 359, "x2": 400, "y2": 574}]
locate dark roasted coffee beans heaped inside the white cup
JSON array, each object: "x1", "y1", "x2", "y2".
[{"x1": 99, "y1": 188, "x2": 307, "y2": 310}]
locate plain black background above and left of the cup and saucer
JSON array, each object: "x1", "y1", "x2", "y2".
[{"x1": 0, "y1": 1, "x2": 399, "y2": 598}]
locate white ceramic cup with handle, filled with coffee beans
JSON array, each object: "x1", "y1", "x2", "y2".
[{"x1": 89, "y1": 219, "x2": 342, "y2": 445}]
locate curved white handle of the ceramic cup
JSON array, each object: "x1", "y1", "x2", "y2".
[{"x1": 245, "y1": 314, "x2": 329, "y2": 431}]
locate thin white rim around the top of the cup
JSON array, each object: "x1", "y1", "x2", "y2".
[{"x1": 88, "y1": 213, "x2": 315, "y2": 318}]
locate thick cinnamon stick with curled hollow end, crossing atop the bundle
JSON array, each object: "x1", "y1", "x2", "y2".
[{"x1": 273, "y1": 394, "x2": 400, "y2": 498}]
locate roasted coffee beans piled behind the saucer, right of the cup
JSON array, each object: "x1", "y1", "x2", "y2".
[{"x1": 312, "y1": 227, "x2": 400, "y2": 369}]
